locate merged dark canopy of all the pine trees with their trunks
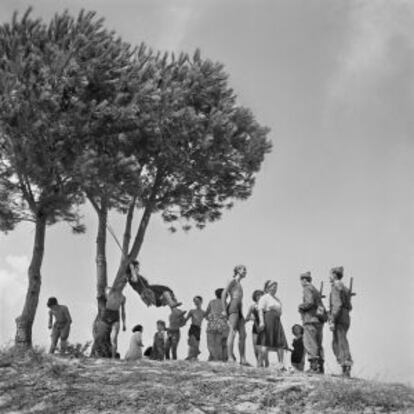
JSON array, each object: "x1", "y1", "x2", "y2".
[{"x1": 0, "y1": 9, "x2": 271, "y2": 350}]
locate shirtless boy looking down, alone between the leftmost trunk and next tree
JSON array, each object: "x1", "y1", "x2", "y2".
[{"x1": 46, "y1": 297, "x2": 72, "y2": 354}]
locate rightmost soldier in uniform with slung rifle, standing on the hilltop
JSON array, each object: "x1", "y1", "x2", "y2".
[{"x1": 329, "y1": 266, "x2": 354, "y2": 378}]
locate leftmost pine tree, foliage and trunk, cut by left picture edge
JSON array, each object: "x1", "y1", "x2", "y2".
[{"x1": 0, "y1": 9, "x2": 86, "y2": 346}]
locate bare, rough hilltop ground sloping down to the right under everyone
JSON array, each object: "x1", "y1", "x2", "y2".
[{"x1": 0, "y1": 350, "x2": 414, "y2": 414}]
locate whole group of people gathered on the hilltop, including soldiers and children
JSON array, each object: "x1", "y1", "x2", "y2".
[{"x1": 48, "y1": 261, "x2": 352, "y2": 377}]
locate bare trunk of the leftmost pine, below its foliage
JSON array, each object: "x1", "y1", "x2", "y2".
[{"x1": 15, "y1": 214, "x2": 46, "y2": 347}]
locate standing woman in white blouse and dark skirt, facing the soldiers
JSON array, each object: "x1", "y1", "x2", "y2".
[{"x1": 257, "y1": 280, "x2": 289, "y2": 369}]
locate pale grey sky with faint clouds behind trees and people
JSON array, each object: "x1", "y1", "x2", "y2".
[{"x1": 0, "y1": 0, "x2": 414, "y2": 384}]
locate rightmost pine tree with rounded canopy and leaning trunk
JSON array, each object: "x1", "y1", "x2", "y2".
[{"x1": 110, "y1": 51, "x2": 271, "y2": 288}]
